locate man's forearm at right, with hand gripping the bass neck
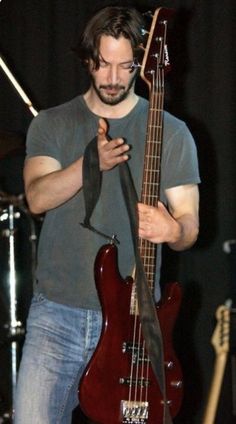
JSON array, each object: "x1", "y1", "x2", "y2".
[{"x1": 138, "y1": 184, "x2": 199, "y2": 250}]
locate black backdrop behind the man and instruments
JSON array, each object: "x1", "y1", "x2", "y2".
[{"x1": 0, "y1": 0, "x2": 236, "y2": 424}]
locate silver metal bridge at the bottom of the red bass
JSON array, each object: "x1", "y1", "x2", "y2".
[{"x1": 121, "y1": 400, "x2": 148, "y2": 424}]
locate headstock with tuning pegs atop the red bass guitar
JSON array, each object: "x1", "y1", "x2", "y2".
[{"x1": 140, "y1": 7, "x2": 173, "y2": 88}]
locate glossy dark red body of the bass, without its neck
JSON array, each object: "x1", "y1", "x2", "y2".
[{"x1": 79, "y1": 244, "x2": 183, "y2": 424}]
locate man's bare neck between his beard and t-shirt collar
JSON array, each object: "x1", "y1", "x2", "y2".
[{"x1": 84, "y1": 87, "x2": 138, "y2": 119}]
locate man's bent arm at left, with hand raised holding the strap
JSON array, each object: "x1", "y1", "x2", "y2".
[{"x1": 24, "y1": 119, "x2": 129, "y2": 214}]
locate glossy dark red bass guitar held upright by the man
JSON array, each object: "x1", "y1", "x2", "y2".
[{"x1": 79, "y1": 8, "x2": 183, "y2": 424}]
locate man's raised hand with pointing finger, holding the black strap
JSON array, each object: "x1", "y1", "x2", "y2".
[{"x1": 98, "y1": 118, "x2": 129, "y2": 171}]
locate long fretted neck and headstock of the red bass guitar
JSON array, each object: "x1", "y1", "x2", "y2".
[{"x1": 131, "y1": 8, "x2": 173, "y2": 310}]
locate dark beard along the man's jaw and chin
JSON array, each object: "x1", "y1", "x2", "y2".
[{"x1": 91, "y1": 72, "x2": 137, "y2": 106}]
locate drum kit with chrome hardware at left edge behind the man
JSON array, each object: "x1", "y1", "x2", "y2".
[{"x1": 0, "y1": 56, "x2": 41, "y2": 424}]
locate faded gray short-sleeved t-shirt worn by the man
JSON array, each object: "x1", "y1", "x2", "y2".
[{"x1": 27, "y1": 96, "x2": 200, "y2": 309}]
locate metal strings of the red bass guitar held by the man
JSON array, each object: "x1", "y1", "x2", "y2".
[{"x1": 129, "y1": 29, "x2": 164, "y2": 418}]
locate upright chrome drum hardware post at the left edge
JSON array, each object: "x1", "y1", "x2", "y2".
[{"x1": 0, "y1": 204, "x2": 25, "y2": 418}]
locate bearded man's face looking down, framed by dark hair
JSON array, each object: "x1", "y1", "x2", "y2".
[{"x1": 90, "y1": 35, "x2": 137, "y2": 105}]
